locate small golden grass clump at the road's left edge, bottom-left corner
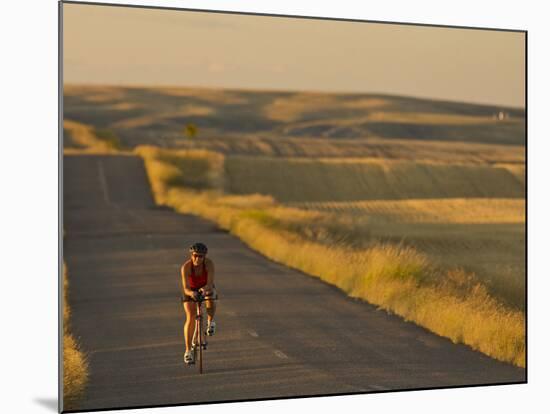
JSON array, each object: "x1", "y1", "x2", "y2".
[{"x1": 63, "y1": 264, "x2": 88, "y2": 409}]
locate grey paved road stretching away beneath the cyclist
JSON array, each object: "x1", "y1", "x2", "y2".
[{"x1": 64, "y1": 156, "x2": 525, "y2": 410}]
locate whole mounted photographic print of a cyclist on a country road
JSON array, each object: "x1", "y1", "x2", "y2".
[{"x1": 59, "y1": 1, "x2": 527, "y2": 412}]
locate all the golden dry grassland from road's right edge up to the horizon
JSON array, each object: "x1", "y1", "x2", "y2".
[{"x1": 64, "y1": 86, "x2": 525, "y2": 366}]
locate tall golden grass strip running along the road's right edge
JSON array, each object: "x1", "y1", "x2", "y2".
[{"x1": 140, "y1": 150, "x2": 525, "y2": 367}]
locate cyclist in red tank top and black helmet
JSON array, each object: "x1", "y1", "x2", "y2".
[{"x1": 181, "y1": 243, "x2": 216, "y2": 364}]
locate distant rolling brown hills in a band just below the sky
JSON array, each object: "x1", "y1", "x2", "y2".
[{"x1": 64, "y1": 85, "x2": 525, "y2": 149}]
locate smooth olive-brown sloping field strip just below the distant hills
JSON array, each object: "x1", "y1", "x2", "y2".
[{"x1": 225, "y1": 156, "x2": 525, "y2": 202}]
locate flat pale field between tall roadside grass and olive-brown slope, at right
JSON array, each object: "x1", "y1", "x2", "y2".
[{"x1": 284, "y1": 199, "x2": 525, "y2": 310}]
